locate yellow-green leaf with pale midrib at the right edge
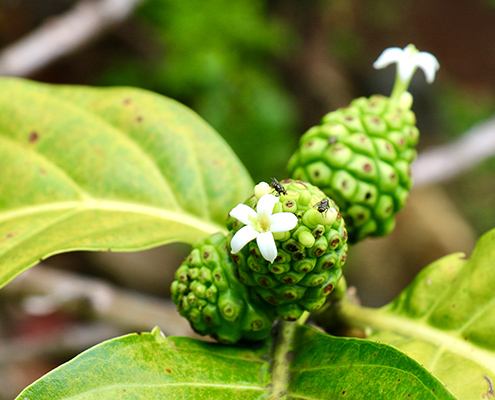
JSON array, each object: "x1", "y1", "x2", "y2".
[{"x1": 342, "y1": 230, "x2": 495, "y2": 400}]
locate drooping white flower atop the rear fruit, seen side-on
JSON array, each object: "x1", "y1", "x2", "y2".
[{"x1": 373, "y1": 44, "x2": 440, "y2": 83}]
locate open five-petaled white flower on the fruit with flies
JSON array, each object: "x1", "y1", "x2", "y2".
[{"x1": 230, "y1": 194, "x2": 297, "y2": 263}]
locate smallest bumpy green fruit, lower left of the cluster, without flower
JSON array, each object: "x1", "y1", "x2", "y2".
[{"x1": 171, "y1": 233, "x2": 276, "y2": 343}]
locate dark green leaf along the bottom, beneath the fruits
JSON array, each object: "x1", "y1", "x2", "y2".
[{"x1": 17, "y1": 327, "x2": 453, "y2": 400}]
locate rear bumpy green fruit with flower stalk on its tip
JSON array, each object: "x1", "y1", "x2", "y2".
[{"x1": 288, "y1": 95, "x2": 419, "y2": 243}]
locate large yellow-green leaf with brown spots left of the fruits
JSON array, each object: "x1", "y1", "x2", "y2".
[{"x1": 0, "y1": 78, "x2": 253, "y2": 287}]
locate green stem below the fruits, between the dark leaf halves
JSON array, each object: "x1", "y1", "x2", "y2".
[{"x1": 270, "y1": 320, "x2": 298, "y2": 400}]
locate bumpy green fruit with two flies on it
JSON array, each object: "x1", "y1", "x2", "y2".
[{"x1": 227, "y1": 179, "x2": 347, "y2": 320}]
